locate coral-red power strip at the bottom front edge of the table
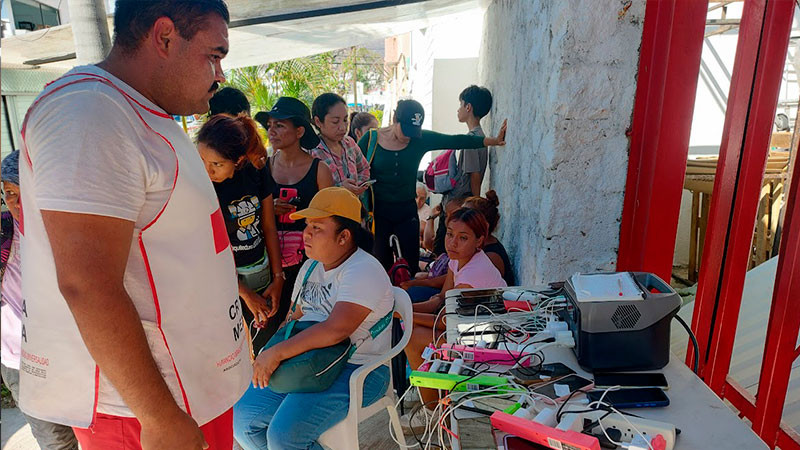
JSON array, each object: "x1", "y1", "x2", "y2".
[{"x1": 490, "y1": 411, "x2": 600, "y2": 450}]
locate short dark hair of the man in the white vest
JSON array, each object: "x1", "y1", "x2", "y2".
[{"x1": 114, "y1": 0, "x2": 230, "y2": 52}]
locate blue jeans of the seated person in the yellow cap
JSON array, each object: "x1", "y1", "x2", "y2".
[{"x1": 233, "y1": 364, "x2": 389, "y2": 450}]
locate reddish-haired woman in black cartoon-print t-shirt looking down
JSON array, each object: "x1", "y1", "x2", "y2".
[{"x1": 197, "y1": 114, "x2": 285, "y2": 349}]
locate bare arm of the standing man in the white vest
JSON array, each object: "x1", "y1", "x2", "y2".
[{"x1": 42, "y1": 211, "x2": 205, "y2": 449}]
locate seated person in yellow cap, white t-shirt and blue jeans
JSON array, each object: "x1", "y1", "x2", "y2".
[{"x1": 233, "y1": 187, "x2": 394, "y2": 450}]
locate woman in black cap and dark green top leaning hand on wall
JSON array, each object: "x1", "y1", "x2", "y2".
[{"x1": 358, "y1": 100, "x2": 506, "y2": 273}]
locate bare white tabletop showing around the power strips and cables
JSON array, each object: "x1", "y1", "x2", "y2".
[{"x1": 445, "y1": 287, "x2": 769, "y2": 450}]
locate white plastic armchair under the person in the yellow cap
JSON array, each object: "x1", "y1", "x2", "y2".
[{"x1": 317, "y1": 287, "x2": 414, "y2": 450}]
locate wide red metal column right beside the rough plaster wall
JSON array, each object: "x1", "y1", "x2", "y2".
[{"x1": 617, "y1": 1, "x2": 708, "y2": 282}]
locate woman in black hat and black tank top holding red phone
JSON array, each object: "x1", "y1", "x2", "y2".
[{"x1": 255, "y1": 97, "x2": 333, "y2": 336}]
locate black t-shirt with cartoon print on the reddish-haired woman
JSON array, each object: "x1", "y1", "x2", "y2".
[{"x1": 213, "y1": 163, "x2": 275, "y2": 267}]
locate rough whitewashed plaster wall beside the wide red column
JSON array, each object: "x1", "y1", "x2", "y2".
[{"x1": 479, "y1": 0, "x2": 645, "y2": 285}]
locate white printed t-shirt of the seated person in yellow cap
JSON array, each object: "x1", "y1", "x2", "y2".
[{"x1": 292, "y1": 249, "x2": 394, "y2": 364}]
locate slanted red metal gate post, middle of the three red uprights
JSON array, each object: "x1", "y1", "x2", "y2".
[{"x1": 687, "y1": 0, "x2": 794, "y2": 393}]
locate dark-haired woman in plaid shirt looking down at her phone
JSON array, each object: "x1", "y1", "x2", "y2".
[{"x1": 311, "y1": 92, "x2": 376, "y2": 196}]
